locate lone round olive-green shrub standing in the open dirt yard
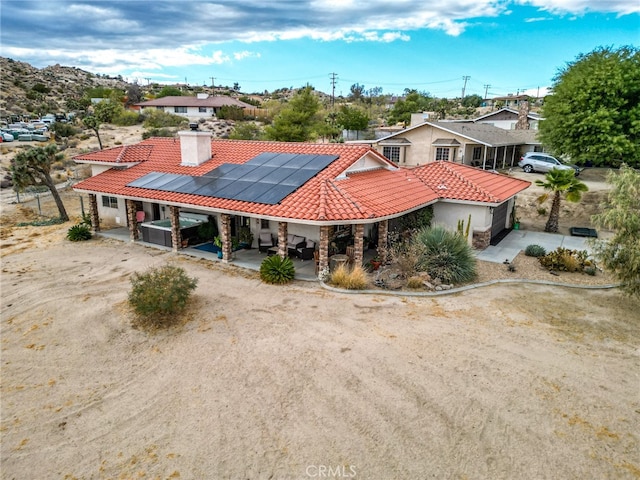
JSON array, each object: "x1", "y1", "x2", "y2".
[{"x1": 129, "y1": 265, "x2": 198, "y2": 328}]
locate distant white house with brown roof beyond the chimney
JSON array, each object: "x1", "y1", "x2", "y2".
[{"x1": 136, "y1": 93, "x2": 255, "y2": 119}]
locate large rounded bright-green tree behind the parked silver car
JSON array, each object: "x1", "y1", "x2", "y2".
[{"x1": 539, "y1": 46, "x2": 640, "y2": 167}]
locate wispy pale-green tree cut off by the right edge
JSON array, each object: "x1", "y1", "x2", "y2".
[{"x1": 591, "y1": 164, "x2": 640, "y2": 297}]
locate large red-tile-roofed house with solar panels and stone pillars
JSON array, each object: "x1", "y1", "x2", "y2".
[{"x1": 74, "y1": 130, "x2": 530, "y2": 267}]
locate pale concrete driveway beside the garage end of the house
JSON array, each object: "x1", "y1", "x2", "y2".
[{"x1": 476, "y1": 230, "x2": 592, "y2": 263}]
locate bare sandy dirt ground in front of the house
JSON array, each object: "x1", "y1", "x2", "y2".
[{"x1": 0, "y1": 129, "x2": 640, "y2": 479}]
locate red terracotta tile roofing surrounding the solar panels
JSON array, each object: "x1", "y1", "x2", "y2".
[{"x1": 74, "y1": 138, "x2": 529, "y2": 221}]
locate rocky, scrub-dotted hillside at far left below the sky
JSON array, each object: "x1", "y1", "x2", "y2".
[{"x1": 0, "y1": 57, "x2": 129, "y2": 120}]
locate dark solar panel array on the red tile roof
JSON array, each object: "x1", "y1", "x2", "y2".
[{"x1": 127, "y1": 152, "x2": 338, "y2": 205}]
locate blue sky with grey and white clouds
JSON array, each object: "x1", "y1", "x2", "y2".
[{"x1": 0, "y1": 0, "x2": 640, "y2": 98}]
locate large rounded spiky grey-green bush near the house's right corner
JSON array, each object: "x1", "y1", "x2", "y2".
[{"x1": 414, "y1": 226, "x2": 476, "y2": 284}]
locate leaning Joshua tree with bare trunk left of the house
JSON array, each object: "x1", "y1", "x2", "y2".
[{"x1": 10, "y1": 144, "x2": 69, "y2": 222}]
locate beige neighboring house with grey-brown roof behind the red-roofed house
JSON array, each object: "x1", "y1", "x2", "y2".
[{"x1": 348, "y1": 121, "x2": 540, "y2": 169}]
